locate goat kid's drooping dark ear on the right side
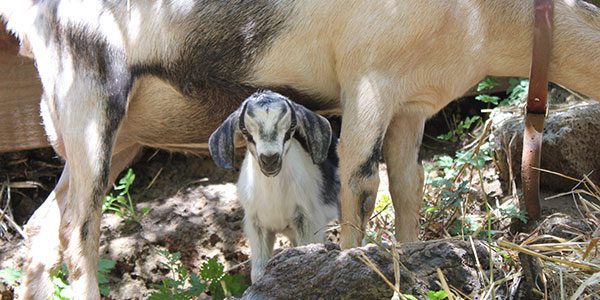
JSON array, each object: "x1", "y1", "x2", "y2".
[{"x1": 293, "y1": 103, "x2": 332, "y2": 164}]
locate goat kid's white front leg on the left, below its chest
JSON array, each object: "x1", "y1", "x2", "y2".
[{"x1": 244, "y1": 218, "x2": 275, "y2": 283}]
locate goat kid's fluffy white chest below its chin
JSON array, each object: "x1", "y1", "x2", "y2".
[{"x1": 237, "y1": 139, "x2": 323, "y2": 232}]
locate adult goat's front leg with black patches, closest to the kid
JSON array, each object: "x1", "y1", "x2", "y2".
[{"x1": 338, "y1": 81, "x2": 393, "y2": 249}]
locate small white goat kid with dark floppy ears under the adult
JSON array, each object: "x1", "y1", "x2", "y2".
[{"x1": 209, "y1": 91, "x2": 339, "y2": 282}]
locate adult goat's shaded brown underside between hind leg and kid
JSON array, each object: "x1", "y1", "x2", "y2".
[{"x1": 119, "y1": 76, "x2": 238, "y2": 152}]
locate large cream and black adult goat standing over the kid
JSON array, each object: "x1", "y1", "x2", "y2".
[{"x1": 0, "y1": 0, "x2": 600, "y2": 298}]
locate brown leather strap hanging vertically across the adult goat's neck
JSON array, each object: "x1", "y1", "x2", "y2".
[{"x1": 521, "y1": 0, "x2": 554, "y2": 219}]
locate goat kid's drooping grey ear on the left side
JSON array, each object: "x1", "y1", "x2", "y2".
[{"x1": 208, "y1": 102, "x2": 246, "y2": 169}]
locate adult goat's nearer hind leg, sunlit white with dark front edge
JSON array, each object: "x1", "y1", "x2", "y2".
[{"x1": 58, "y1": 78, "x2": 128, "y2": 299}]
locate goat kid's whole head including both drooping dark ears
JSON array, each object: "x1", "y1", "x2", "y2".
[{"x1": 209, "y1": 91, "x2": 331, "y2": 177}]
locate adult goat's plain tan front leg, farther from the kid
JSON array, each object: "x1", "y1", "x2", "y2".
[{"x1": 383, "y1": 114, "x2": 426, "y2": 242}]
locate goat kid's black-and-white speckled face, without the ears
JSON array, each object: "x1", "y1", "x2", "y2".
[{"x1": 240, "y1": 92, "x2": 297, "y2": 177}]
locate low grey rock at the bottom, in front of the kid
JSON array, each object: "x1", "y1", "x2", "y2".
[{"x1": 242, "y1": 240, "x2": 489, "y2": 299}]
